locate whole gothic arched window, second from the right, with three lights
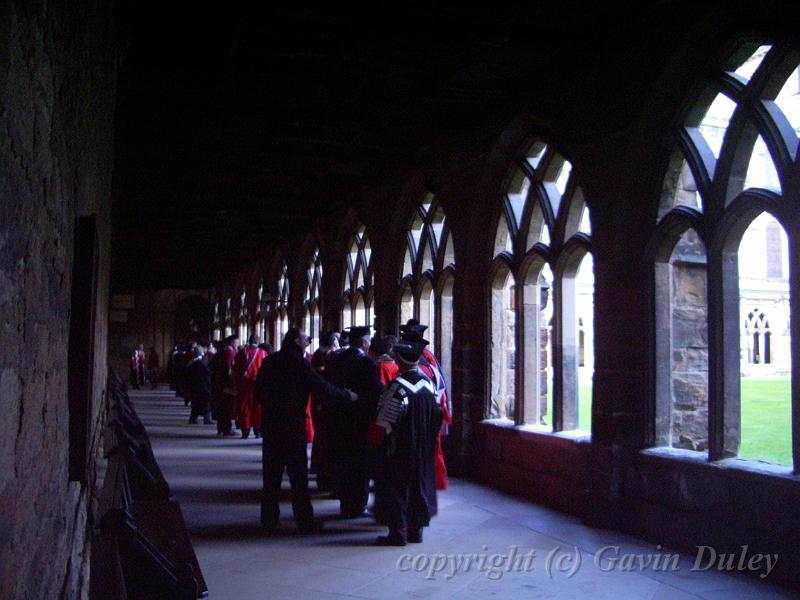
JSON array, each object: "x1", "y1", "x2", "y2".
[{"x1": 487, "y1": 141, "x2": 594, "y2": 431}]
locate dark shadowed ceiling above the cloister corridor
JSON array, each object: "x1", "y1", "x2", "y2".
[{"x1": 112, "y1": 0, "x2": 680, "y2": 290}]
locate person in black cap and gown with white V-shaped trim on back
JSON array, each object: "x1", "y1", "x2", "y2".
[{"x1": 375, "y1": 340, "x2": 443, "y2": 546}]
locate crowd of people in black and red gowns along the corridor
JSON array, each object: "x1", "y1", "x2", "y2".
[{"x1": 164, "y1": 320, "x2": 451, "y2": 546}]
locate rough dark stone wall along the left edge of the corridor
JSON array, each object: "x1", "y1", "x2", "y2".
[{"x1": 0, "y1": 0, "x2": 116, "y2": 598}]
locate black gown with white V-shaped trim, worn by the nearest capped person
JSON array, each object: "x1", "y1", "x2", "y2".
[{"x1": 375, "y1": 371, "x2": 444, "y2": 529}]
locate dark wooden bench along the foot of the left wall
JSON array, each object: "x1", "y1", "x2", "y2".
[{"x1": 91, "y1": 378, "x2": 208, "y2": 600}]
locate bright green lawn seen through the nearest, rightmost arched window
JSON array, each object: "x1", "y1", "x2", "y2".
[{"x1": 739, "y1": 377, "x2": 792, "y2": 465}]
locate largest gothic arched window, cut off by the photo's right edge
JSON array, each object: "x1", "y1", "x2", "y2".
[{"x1": 651, "y1": 42, "x2": 800, "y2": 465}]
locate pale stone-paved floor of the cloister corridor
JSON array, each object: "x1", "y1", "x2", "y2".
[{"x1": 131, "y1": 390, "x2": 796, "y2": 600}]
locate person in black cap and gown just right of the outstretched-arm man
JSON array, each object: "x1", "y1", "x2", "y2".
[{"x1": 326, "y1": 327, "x2": 383, "y2": 519}]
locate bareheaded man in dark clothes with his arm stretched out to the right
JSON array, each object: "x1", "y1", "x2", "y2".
[{"x1": 255, "y1": 327, "x2": 358, "y2": 532}]
